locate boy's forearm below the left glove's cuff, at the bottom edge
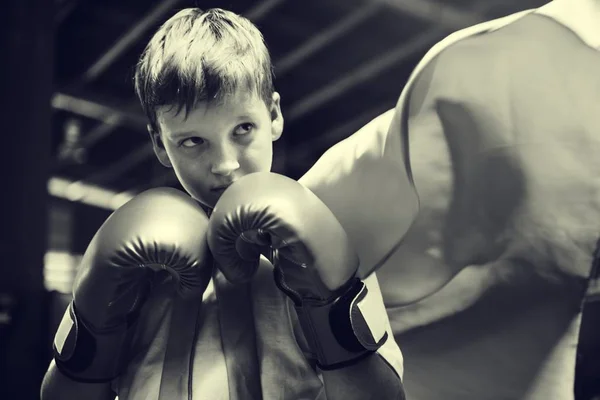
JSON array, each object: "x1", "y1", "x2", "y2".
[{"x1": 41, "y1": 360, "x2": 115, "y2": 400}]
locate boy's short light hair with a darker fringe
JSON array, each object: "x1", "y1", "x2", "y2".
[{"x1": 134, "y1": 8, "x2": 274, "y2": 131}]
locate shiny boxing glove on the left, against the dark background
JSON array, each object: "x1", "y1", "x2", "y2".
[{"x1": 53, "y1": 188, "x2": 212, "y2": 382}]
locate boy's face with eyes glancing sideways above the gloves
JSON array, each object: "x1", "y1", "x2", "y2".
[{"x1": 151, "y1": 93, "x2": 283, "y2": 207}]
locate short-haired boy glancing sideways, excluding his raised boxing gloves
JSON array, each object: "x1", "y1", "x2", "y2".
[{"x1": 42, "y1": 9, "x2": 404, "y2": 400}]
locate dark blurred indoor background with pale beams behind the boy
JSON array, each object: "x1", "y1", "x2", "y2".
[{"x1": 0, "y1": 0, "x2": 545, "y2": 400}]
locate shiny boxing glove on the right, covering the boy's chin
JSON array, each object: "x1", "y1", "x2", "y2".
[{"x1": 207, "y1": 172, "x2": 387, "y2": 369}]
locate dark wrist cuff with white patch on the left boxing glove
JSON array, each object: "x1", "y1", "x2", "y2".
[{"x1": 53, "y1": 302, "x2": 131, "y2": 383}]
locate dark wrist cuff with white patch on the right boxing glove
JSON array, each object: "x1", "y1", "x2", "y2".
[{"x1": 276, "y1": 269, "x2": 388, "y2": 370}]
